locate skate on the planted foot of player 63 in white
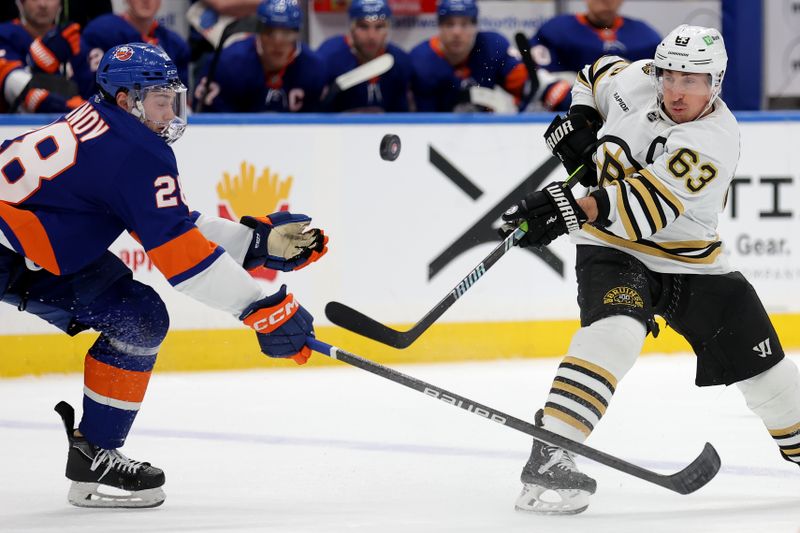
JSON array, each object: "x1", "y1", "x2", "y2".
[{"x1": 515, "y1": 411, "x2": 597, "y2": 514}]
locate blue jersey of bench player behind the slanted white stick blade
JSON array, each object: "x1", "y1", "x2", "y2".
[{"x1": 317, "y1": 35, "x2": 411, "y2": 113}]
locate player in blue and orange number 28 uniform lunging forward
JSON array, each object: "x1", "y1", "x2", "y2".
[{"x1": 0, "y1": 43, "x2": 327, "y2": 507}]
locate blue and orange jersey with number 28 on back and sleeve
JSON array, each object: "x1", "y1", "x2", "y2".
[{"x1": 0, "y1": 98, "x2": 222, "y2": 285}]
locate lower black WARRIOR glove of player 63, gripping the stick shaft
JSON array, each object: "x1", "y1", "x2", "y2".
[{"x1": 500, "y1": 181, "x2": 588, "y2": 248}]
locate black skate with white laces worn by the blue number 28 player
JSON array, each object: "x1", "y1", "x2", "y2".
[{"x1": 55, "y1": 402, "x2": 166, "y2": 507}]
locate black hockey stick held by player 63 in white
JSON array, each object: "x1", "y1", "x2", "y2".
[{"x1": 325, "y1": 165, "x2": 584, "y2": 349}]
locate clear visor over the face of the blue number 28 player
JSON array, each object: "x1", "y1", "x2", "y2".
[{"x1": 136, "y1": 82, "x2": 187, "y2": 144}]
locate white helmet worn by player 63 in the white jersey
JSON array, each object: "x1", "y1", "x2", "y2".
[{"x1": 652, "y1": 24, "x2": 728, "y2": 107}]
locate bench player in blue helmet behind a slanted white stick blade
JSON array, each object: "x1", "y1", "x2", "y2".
[{"x1": 317, "y1": 0, "x2": 411, "y2": 112}]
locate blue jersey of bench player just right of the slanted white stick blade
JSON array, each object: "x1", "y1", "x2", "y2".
[{"x1": 411, "y1": 31, "x2": 528, "y2": 111}]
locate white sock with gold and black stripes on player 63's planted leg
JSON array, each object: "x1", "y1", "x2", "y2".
[{"x1": 543, "y1": 315, "x2": 647, "y2": 442}]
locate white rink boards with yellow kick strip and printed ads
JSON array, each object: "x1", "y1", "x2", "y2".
[{"x1": 0, "y1": 113, "x2": 800, "y2": 376}]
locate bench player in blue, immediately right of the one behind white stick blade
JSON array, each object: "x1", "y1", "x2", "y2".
[{"x1": 411, "y1": 0, "x2": 528, "y2": 111}]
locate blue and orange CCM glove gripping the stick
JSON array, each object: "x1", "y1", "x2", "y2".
[{"x1": 239, "y1": 285, "x2": 314, "y2": 365}]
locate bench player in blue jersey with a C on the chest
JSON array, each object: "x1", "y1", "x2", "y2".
[{"x1": 195, "y1": 0, "x2": 325, "y2": 113}]
